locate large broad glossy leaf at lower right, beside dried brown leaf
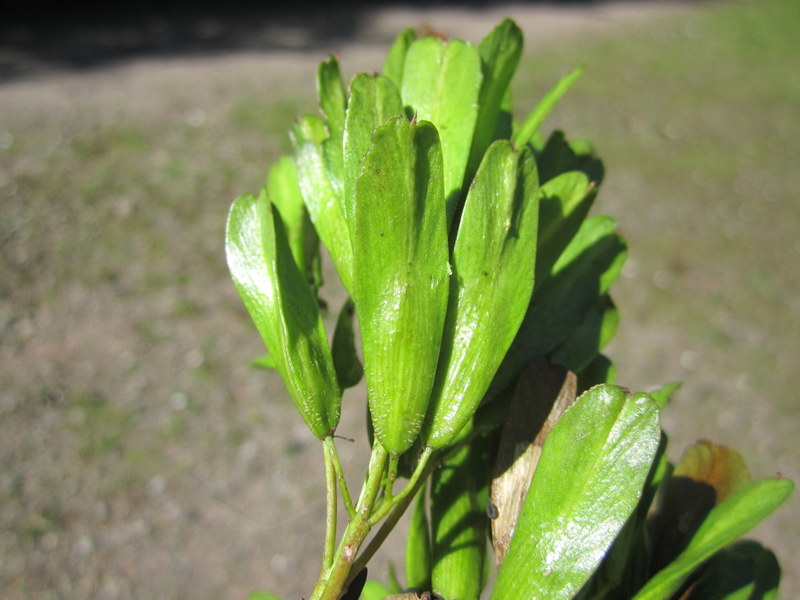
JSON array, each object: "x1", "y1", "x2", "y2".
[{"x1": 492, "y1": 386, "x2": 665, "y2": 600}]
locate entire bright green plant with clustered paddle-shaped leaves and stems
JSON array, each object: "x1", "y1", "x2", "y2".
[{"x1": 227, "y1": 20, "x2": 792, "y2": 600}]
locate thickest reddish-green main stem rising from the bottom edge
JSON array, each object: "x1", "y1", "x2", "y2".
[{"x1": 310, "y1": 442, "x2": 389, "y2": 600}]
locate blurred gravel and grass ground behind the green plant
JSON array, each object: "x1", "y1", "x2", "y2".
[{"x1": 0, "y1": 0, "x2": 800, "y2": 600}]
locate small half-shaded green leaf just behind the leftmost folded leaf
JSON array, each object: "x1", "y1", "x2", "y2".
[{"x1": 267, "y1": 156, "x2": 322, "y2": 288}]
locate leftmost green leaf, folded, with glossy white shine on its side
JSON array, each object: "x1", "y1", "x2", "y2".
[{"x1": 225, "y1": 189, "x2": 341, "y2": 438}]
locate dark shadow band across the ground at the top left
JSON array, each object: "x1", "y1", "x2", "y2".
[{"x1": 0, "y1": 0, "x2": 664, "y2": 82}]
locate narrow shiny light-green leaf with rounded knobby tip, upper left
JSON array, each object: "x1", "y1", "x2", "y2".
[{"x1": 292, "y1": 116, "x2": 353, "y2": 291}]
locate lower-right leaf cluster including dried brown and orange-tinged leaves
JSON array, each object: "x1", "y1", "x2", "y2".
[{"x1": 362, "y1": 382, "x2": 793, "y2": 600}]
